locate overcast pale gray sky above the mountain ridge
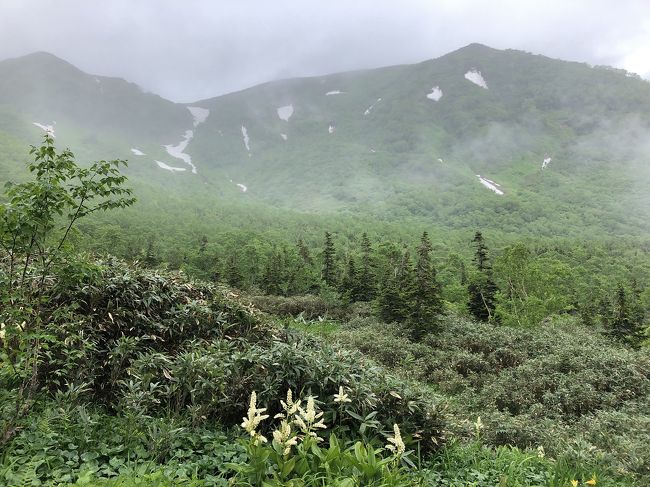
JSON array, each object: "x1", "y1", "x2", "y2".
[{"x1": 0, "y1": 0, "x2": 650, "y2": 102}]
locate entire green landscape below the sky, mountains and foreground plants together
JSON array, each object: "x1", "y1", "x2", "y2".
[{"x1": 0, "y1": 44, "x2": 650, "y2": 487}]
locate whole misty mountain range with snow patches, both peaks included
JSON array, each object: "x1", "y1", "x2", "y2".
[{"x1": 0, "y1": 44, "x2": 650, "y2": 235}]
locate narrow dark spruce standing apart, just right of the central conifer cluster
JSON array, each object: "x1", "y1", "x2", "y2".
[{"x1": 467, "y1": 232, "x2": 498, "y2": 322}]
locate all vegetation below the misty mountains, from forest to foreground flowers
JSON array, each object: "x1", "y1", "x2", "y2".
[{"x1": 0, "y1": 135, "x2": 650, "y2": 486}]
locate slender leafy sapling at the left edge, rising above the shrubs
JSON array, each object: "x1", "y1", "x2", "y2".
[{"x1": 0, "y1": 134, "x2": 135, "y2": 445}]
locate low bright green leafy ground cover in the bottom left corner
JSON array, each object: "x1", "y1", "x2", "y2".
[{"x1": 0, "y1": 404, "x2": 246, "y2": 486}]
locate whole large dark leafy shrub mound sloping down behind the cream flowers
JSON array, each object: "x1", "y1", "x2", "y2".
[{"x1": 0, "y1": 259, "x2": 445, "y2": 486}]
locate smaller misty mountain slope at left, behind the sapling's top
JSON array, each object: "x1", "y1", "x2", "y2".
[{"x1": 0, "y1": 53, "x2": 192, "y2": 173}]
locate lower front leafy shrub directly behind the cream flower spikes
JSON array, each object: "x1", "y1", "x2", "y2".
[{"x1": 120, "y1": 335, "x2": 444, "y2": 449}]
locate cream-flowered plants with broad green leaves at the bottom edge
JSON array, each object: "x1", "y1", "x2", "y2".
[{"x1": 232, "y1": 386, "x2": 414, "y2": 486}]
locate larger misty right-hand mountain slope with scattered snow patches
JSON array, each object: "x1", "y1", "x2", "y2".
[{"x1": 181, "y1": 45, "x2": 650, "y2": 234}]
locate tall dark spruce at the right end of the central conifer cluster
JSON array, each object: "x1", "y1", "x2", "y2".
[{"x1": 410, "y1": 232, "x2": 443, "y2": 338}]
